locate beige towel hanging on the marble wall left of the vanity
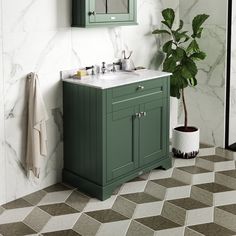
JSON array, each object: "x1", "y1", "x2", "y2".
[{"x1": 26, "y1": 73, "x2": 48, "y2": 178}]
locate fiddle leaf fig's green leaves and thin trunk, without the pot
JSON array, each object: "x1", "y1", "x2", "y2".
[{"x1": 152, "y1": 8, "x2": 209, "y2": 131}]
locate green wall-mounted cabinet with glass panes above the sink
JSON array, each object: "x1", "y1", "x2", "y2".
[{"x1": 72, "y1": 0, "x2": 137, "y2": 27}]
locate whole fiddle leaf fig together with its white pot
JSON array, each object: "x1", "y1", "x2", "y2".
[{"x1": 153, "y1": 8, "x2": 209, "y2": 159}]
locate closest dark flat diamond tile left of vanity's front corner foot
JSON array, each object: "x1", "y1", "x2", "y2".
[{"x1": 39, "y1": 203, "x2": 78, "y2": 216}]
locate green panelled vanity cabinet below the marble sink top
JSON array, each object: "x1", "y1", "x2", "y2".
[{"x1": 63, "y1": 76, "x2": 171, "y2": 200}]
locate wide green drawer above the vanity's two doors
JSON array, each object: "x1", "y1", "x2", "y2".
[{"x1": 107, "y1": 77, "x2": 169, "y2": 113}]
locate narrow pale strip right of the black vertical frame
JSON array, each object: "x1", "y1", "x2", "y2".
[{"x1": 229, "y1": 1, "x2": 236, "y2": 145}]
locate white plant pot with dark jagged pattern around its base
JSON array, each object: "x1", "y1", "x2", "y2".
[{"x1": 172, "y1": 127, "x2": 200, "y2": 159}]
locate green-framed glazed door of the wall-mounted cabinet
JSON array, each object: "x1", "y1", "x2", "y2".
[{"x1": 88, "y1": 0, "x2": 136, "y2": 23}]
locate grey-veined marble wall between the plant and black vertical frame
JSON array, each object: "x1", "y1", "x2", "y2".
[{"x1": 179, "y1": 0, "x2": 227, "y2": 146}]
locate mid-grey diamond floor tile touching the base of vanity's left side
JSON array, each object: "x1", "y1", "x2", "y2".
[{"x1": 66, "y1": 191, "x2": 90, "y2": 211}]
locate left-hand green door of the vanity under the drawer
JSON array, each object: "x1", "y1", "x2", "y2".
[{"x1": 106, "y1": 106, "x2": 139, "y2": 181}]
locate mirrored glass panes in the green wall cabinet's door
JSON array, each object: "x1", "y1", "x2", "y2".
[{"x1": 95, "y1": 0, "x2": 129, "y2": 14}]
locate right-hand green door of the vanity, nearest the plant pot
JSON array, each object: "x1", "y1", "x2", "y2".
[{"x1": 139, "y1": 99, "x2": 169, "y2": 166}]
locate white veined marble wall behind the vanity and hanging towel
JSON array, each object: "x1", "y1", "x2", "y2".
[{"x1": 0, "y1": 0, "x2": 179, "y2": 204}]
